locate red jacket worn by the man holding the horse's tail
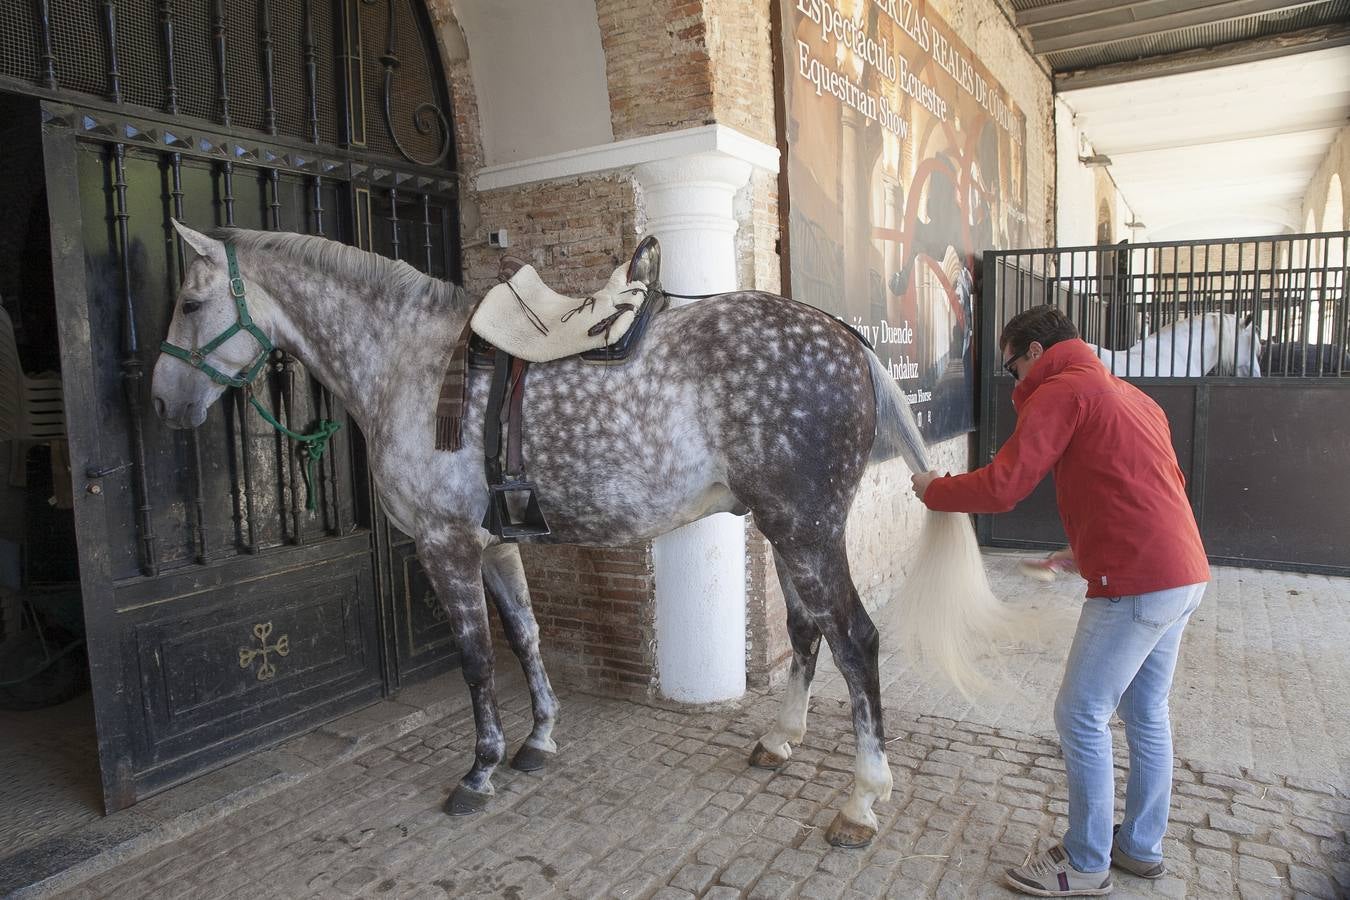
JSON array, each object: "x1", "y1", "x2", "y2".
[{"x1": 923, "y1": 340, "x2": 1210, "y2": 596}]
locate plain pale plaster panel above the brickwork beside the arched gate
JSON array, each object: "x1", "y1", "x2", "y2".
[{"x1": 452, "y1": 0, "x2": 614, "y2": 166}]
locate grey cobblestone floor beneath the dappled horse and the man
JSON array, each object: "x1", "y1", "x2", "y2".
[{"x1": 29, "y1": 560, "x2": 1350, "y2": 900}]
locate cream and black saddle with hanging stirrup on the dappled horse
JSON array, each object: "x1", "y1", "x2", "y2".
[{"x1": 470, "y1": 236, "x2": 670, "y2": 541}]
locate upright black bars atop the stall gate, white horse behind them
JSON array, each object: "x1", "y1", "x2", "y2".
[{"x1": 983, "y1": 232, "x2": 1350, "y2": 378}]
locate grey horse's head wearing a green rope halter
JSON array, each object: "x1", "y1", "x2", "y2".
[{"x1": 151, "y1": 221, "x2": 273, "y2": 428}]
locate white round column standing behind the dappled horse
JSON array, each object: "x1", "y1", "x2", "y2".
[{"x1": 636, "y1": 152, "x2": 752, "y2": 703}]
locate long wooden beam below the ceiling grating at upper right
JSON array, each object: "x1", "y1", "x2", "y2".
[{"x1": 1054, "y1": 23, "x2": 1350, "y2": 93}]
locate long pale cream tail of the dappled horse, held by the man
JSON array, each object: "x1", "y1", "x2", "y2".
[{"x1": 867, "y1": 352, "x2": 1013, "y2": 696}]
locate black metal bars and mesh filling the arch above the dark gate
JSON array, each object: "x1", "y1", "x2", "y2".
[{"x1": 0, "y1": 0, "x2": 455, "y2": 170}]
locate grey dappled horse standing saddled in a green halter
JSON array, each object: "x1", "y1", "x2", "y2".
[{"x1": 153, "y1": 223, "x2": 998, "y2": 846}]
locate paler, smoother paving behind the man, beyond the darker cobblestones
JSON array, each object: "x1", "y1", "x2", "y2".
[{"x1": 847, "y1": 553, "x2": 1350, "y2": 785}]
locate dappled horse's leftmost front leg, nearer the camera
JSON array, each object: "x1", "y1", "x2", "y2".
[{"x1": 417, "y1": 529, "x2": 506, "y2": 815}]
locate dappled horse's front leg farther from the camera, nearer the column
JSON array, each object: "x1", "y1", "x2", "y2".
[{"x1": 483, "y1": 544, "x2": 558, "y2": 772}]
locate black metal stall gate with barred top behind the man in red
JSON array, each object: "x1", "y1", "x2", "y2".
[{"x1": 977, "y1": 232, "x2": 1350, "y2": 575}]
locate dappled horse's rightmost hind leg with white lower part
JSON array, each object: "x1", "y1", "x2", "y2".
[{"x1": 775, "y1": 536, "x2": 892, "y2": 847}]
